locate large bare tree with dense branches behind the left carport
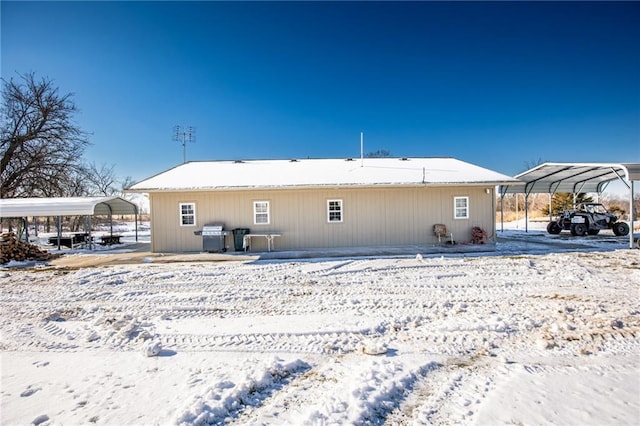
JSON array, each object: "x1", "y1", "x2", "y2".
[{"x1": 0, "y1": 73, "x2": 89, "y2": 198}]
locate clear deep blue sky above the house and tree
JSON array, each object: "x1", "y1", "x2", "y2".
[{"x1": 0, "y1": 1, "x2": 640, "y2": 185}]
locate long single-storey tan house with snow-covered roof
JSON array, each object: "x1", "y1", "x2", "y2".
[{"x1": 127, "y1": 158, "x2": 518, "y2": 252}]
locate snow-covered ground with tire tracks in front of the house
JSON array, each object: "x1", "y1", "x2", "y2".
[{"x1": 0, "y1": 221, "x2": 640, "y2": 425}]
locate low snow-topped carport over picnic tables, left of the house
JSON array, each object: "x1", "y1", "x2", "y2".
[{"x1": 0, "y1": 197, "x2": 138, "y2": 249}]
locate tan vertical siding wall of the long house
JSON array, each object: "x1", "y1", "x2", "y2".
[{"x1": 151, "y1": 187, "x2": 495, "y2": 252}]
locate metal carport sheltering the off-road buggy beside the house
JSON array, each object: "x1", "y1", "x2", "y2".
[{"x1": 499, "y1": 163, "x2": 640, "y2": 248}]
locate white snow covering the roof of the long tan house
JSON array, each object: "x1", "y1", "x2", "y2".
[{"x1": 128, "y1": 158, "x2": 518, "y2": 192}]
